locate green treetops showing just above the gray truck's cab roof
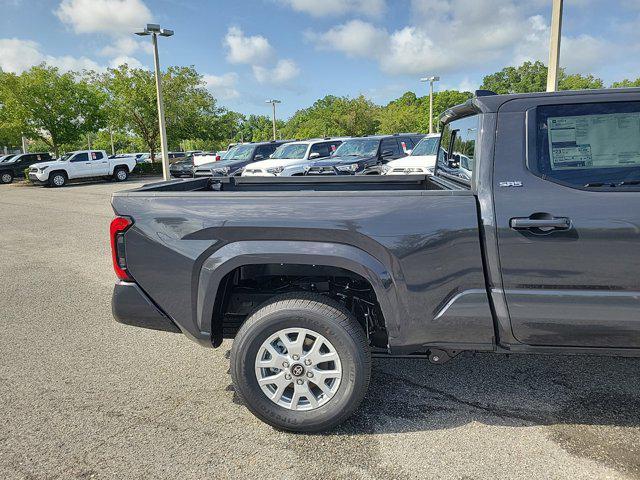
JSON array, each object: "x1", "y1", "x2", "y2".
[{"x1": 480, "y1": 61, "x2": 604, "y2": 93}]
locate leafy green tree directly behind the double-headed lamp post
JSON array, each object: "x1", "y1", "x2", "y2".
[{"x1": 100, "y1": 65, "x2": 225, "y2": 158}]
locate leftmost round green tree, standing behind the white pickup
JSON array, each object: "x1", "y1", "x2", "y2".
[{"x1": 1, "y1": 64, "x2": 105, "y2": 155}]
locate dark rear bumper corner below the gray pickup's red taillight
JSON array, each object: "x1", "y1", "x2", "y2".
[{"x1": 111, "y1": 282, "x2": 181, "y2": 333}]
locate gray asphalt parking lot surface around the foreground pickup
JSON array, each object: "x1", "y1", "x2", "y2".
[{"x1": 0, "y1": 181, "x2": 640, "y2": 479}]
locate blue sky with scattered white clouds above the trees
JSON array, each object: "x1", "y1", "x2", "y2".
[{"x1": 0, "y1": 0, "x2": 640, "y2": 117}]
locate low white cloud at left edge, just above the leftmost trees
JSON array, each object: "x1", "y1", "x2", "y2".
[{"x1": 0, "y1": 38, "x2": 104, "y2": 73}]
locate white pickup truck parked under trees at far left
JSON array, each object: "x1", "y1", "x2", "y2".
[{"x1": 29, "y1": 150, "x2": 136, "y2": 187}]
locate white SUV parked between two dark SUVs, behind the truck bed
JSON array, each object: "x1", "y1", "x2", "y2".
[{"x1": 242, "y1": 138, "x2": 345, "y2": 177}]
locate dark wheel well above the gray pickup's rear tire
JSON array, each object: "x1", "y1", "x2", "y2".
[{"x1": 212, "y1": 263, "x2": 388, "y2": 348}]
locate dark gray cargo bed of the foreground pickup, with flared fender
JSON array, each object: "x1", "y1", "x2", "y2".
[{"x1": 112, "y1": 175, "x2": 493, "y2": 352}]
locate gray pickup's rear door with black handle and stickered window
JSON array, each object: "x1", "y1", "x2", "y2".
[{"x1": 494, "y1": 93, "x2": 640, "y2": 348}]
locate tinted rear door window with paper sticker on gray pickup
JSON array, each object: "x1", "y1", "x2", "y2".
[{"x1": 528, "y1": 102, "x2": 640, "y2": 188}]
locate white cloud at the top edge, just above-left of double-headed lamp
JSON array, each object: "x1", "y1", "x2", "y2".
[{"x1": 54, "y1": 0, "x2": 153, "y2": 35}]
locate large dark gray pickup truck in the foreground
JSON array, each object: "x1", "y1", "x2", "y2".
[{"x1": 111, "y1": 89, "x2": 640, "y2": 432}]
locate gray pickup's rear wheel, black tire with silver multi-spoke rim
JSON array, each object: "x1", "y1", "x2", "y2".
[{"x1": 231, "y1": 293, "x2": 371, "y2": 433}]
